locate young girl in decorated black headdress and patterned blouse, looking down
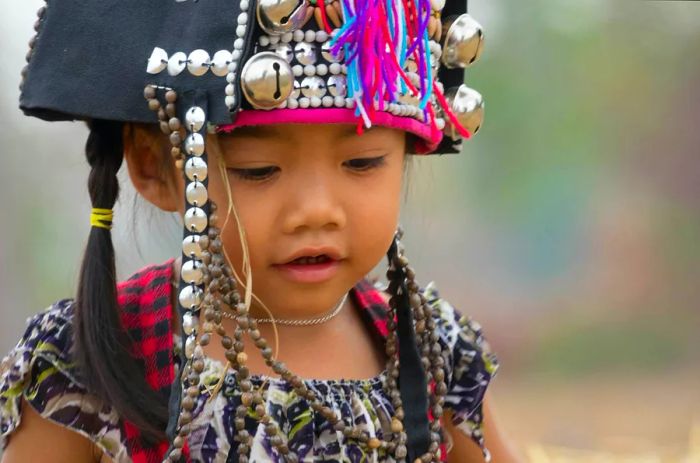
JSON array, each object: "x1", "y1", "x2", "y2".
[{"x1": 0, "y1": 0, "x2": 515, "y2": 463}]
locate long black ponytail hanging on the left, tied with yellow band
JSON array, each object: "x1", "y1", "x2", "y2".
[{"x1": 74, "y1": 119, "x2": 168, "y2": 443}]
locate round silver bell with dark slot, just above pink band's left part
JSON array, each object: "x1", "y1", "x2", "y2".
[{"x1": 241, "y1": 51, "x2": 294, "y2": 109}]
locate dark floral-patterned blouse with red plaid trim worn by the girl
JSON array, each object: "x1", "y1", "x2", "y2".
[{"x1": 0, "y1": 260, "x2": 498, "y2": 463}]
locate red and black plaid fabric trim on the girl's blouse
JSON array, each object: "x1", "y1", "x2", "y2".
[{"x1": 117, "y1": 259, "x2": 434, "y2": 463}]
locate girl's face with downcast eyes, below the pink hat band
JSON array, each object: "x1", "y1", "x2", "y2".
[{"x1": 202, "y1": 125, "x2": 405, "y2": 317}]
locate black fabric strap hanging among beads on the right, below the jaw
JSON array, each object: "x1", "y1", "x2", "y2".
[{"x1": 388, "y1": 240, "x2": 430, "y2": 462}]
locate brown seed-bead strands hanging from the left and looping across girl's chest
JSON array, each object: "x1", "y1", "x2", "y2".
[{"x1": 194, "y1": 220, "x2": 437, "y2": 463}]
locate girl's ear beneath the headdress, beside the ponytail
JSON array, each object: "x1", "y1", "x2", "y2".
[{"x1": 123, "y1": 124, "x2": 185, "y2": 212}]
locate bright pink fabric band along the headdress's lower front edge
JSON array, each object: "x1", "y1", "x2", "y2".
[{"x1": 217, "y1": 108, "x2": 442, "y2": 154}]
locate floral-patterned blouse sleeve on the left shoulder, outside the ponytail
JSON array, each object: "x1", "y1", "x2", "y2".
[{"x1": 0, "y1": 299, "x2": 130, "y2": 461}]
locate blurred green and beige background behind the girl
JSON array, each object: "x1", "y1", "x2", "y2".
[{"x1": 0, "y1": 0, "x2": 700, "y2": 461}]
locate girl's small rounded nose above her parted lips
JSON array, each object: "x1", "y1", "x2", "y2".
[{"x1": 284, "y1": 173, "x2": 346, "y2": 233}]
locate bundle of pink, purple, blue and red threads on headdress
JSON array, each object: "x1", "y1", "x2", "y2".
[{"x1": 331, "y1": 0, "x2": 470, "y2": 138}]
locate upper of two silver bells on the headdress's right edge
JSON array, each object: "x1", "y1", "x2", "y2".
[{"x1": 442, "y1": 13, "x2": 484, "y2": 69}]
